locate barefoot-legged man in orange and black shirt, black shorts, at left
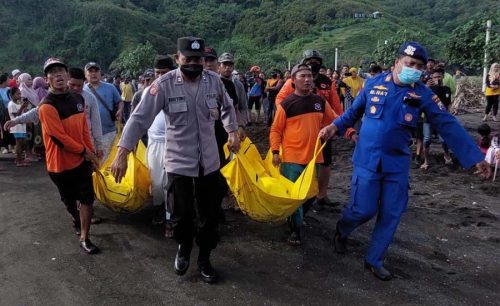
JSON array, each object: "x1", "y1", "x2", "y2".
[{"x1": 39, "y1": 58, "x2": 99, "y2": 254}]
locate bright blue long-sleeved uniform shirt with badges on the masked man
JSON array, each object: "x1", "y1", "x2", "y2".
[{"x1": 333, "y1": 73, "x2": 484, "y2": 173}]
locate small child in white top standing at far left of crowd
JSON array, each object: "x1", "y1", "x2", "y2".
[{"x1": 7, "y1": 87, "x2": 29, "y2": 167}]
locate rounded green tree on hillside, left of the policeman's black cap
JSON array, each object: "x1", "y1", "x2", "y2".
[{"x1": 110, "y1": 41, "x2": 157, "y2": 77}]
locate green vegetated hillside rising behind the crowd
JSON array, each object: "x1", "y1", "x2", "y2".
[{"x1": 0, "y1": 0, "x2": 500, "y2": 73}]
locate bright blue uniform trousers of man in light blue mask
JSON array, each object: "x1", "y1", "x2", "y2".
[{"x1": 339, "y1": 166, "x2": 408, "y2": 268}]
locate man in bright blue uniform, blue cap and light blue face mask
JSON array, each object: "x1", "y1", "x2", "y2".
[{"x1": 320, "y1": 42, "x2": 491, "y2": 280}]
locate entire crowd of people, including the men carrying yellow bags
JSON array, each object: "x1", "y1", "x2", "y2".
[{"x1": 0, "y1": 37, "x2": 500, "y2": 283}]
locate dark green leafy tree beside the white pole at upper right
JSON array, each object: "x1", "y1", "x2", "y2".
[{"x1": 446, "y1": 14, "x2": 500, "y2": 69}]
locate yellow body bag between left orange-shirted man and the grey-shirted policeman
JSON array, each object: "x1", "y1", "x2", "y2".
[{"x1": 93, "y1": 135, "x2": 151, "y2": 213}]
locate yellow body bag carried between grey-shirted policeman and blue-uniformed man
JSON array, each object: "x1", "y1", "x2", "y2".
[{"x1": 221, "y1": 138, "x2": 322, "y2": 222}]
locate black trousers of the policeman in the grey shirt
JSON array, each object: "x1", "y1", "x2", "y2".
[{"x1": 167, "y1": 171, "x2": 220, "y2": 250}]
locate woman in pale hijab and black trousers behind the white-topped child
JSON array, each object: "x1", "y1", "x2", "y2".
[{"x1": 18, "y1": 73, "x2": 43, "y2": 161}]
